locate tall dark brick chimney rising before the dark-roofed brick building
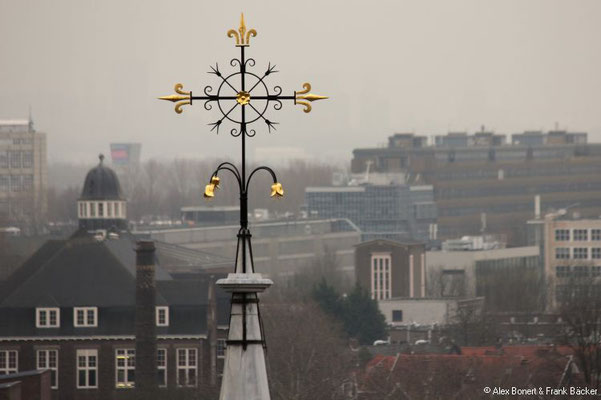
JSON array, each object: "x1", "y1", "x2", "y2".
[{"x1": 135, "y1": 240, "x2": 158, "y2": 400}]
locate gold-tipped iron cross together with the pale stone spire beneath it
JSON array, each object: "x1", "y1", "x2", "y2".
[{"x1": 160, "y1": 14, "x2": 327, "y2": 400}]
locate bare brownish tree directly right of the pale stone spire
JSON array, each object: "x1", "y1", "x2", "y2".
[{"x1": 262, "y1": 298, "x2": 353, "y2": 400}]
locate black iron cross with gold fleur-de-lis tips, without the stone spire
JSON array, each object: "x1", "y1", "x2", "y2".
[{"x1": 159, "y1": 14, "x2": 327, "y2": 273}]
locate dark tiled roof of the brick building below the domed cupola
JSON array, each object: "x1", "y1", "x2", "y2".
[{"x1": 0, "y1": 235, "x2": 229, "y2": 337}]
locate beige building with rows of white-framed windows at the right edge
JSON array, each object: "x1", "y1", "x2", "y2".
[{"x1": 528, "y1": 214, "x2": 601, "y2": 312}]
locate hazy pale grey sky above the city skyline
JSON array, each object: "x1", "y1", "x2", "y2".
[{"x1": 0, "y1": 0, "x2": 601, "y2": 163}]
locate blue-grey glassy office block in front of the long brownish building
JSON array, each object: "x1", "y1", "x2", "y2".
[{"x1": 305, "y1": 184, "x2": 437, "y2": 242}]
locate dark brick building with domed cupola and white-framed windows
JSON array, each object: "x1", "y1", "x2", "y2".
[{"x1": 0, "y1": 158, "x2": 229, "y2": 400}]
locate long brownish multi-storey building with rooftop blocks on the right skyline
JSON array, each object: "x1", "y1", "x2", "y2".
[{"x1": 351, "y1": 131, "x2": 601, "y2": 246}]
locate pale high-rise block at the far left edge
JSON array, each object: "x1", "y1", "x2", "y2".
[{"x1": 0, "y1": 119, "x2": 48, "y2": 232}]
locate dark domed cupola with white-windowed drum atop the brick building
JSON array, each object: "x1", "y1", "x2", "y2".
[{"x1": 77, "y1": 154, "x2": 127, "y2": 231}]
